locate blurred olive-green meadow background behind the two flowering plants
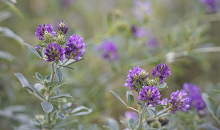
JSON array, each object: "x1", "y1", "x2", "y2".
[{"x1": 0, "y1": 0, "x2": 220, "y2": 130}]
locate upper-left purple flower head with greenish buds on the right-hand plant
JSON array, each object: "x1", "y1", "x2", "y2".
[{"x1": 124, "y1": 66, "x2": 149, "y2": 91}]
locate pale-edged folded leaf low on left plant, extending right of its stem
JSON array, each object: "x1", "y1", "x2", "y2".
[{"x1": 71, "y1": 106, "x2": 92, "y2": 116}]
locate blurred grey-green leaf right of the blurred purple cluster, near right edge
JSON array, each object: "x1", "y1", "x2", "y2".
[{"x1": 202, "y1": 93, "x2": 216, "y2": 116}]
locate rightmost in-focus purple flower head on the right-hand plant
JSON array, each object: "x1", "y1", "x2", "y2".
[{"x1": 169, "y1": 90, "x2": 190, "y2": 114}]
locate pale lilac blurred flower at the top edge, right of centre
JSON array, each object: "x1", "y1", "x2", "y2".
[{"x1": 134, "y1": 0, "x2": 152, "y2": 21}]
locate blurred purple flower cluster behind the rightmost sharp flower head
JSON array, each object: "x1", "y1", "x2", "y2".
[{"x1": 183, "y1": 83, "x2": 206, "y2": 113}]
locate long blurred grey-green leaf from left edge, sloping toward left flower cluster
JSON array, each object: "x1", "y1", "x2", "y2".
[{"x1": 0, "y1": 27, "x2": 24, "y2": 46}]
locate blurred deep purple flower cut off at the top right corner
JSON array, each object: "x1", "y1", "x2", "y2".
[{"x1": 200, "y1": 0, "x2": 219, "y2": 13}]
